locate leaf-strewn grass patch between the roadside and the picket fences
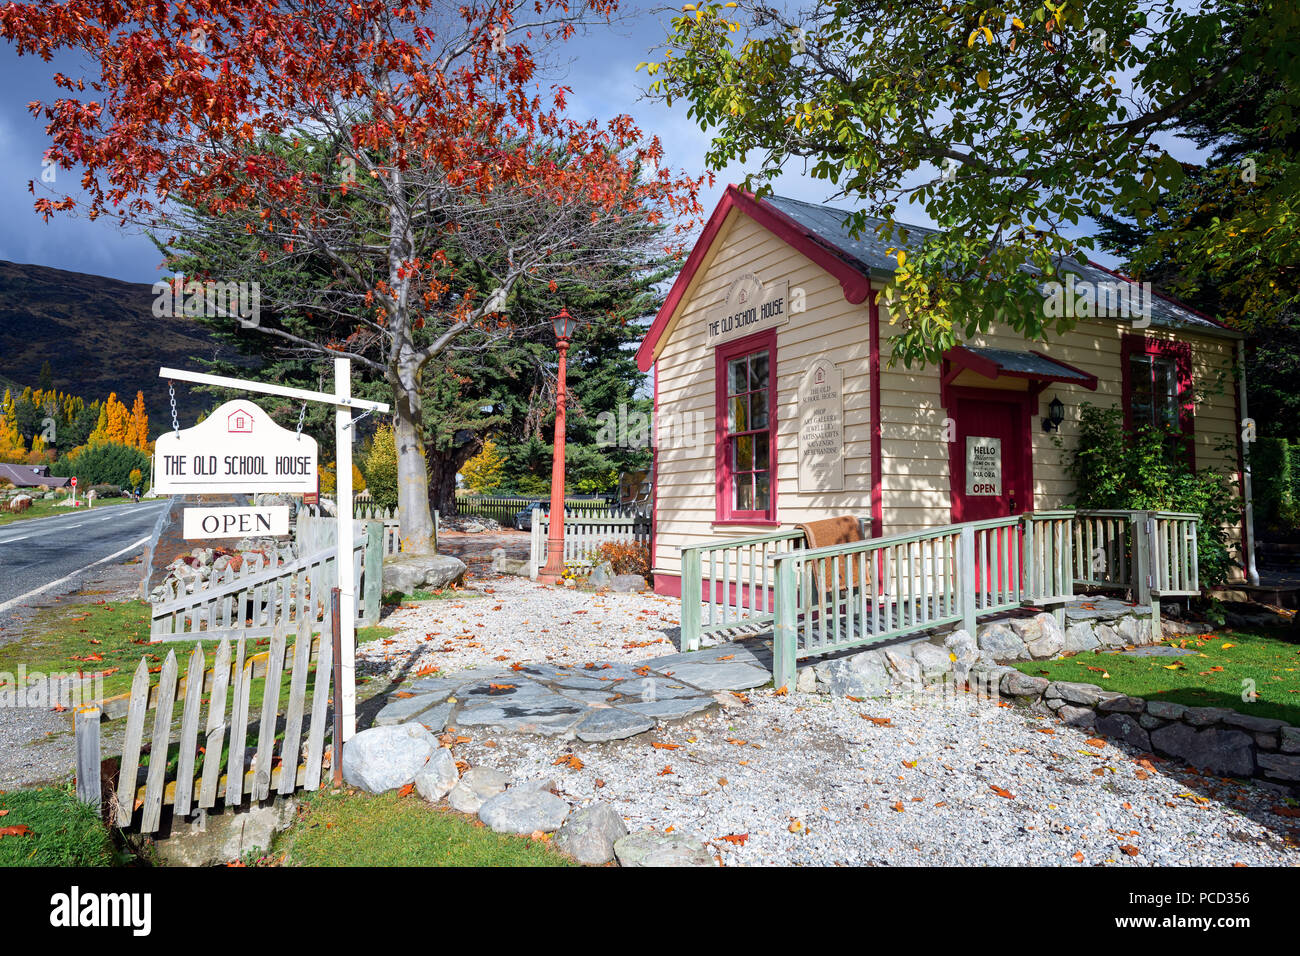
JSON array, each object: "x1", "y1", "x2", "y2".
[{"x1": 0, "y1": 601, "x2": 397, "y2": 701}]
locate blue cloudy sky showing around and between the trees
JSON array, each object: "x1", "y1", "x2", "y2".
[{"x1": 0, "y1": 0, "x2": 1195, "y2": 282}]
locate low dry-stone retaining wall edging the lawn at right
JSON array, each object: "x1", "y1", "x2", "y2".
[{"x1": 970, "y1": 663, "x2": 1300, "y2": 793}]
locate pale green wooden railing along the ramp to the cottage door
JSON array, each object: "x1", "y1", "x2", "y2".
[{"x1": 681, "y1": 510, "x2": 1199, "y2": 687}]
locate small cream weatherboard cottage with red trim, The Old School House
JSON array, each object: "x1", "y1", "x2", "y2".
[{"x1": 637, "y1": 186, "x2": 1242, "y2": 594}]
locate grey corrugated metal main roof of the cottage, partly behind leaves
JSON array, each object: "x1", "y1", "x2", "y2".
[{"x1": 761, "y1": 196, "x2": 1240, "y2": 338}]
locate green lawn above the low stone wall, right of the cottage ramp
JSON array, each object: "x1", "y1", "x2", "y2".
[{"x1": 1015, "y1": 628, "x2": 1300, "y2": 726}]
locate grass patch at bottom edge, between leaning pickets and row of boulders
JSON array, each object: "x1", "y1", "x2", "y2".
[{"x1": 274, "y1": 790, "x2": 575, "y2": 866}]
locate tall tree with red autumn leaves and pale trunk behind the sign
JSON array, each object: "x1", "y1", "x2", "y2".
[{"x1": 0, "y1": 0, "x2": 701, "y2": 550}]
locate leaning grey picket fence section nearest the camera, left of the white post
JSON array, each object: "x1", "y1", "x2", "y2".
[{"x1": 75, "y1": 618, "x2": 334, "y2": 834}]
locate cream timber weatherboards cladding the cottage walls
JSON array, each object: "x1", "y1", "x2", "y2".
[{"x1": 654, "y1": 208, "x2": 1239, "y2": 587}]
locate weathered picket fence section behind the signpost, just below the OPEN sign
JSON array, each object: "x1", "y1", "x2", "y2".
[{"x1": 150, "y1": 522, "x2": 384, "y2": 641}]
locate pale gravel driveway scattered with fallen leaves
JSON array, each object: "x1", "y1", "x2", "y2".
[{"x1": 360, "y1": 579, "x2": 1300, "y2": 866}]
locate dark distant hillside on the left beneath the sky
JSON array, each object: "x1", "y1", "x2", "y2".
[{"x1": 0, "y1": 259, "x2": 253, "y2": 434}]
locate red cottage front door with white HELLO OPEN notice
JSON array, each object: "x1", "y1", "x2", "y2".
[{"x1": 948, "y1": 389, "x2": 1034, "y2": 522}]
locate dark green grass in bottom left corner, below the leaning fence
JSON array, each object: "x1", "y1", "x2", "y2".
[{"x1": 0, "y1": 787, "x2": 117, "y2": 866}]
